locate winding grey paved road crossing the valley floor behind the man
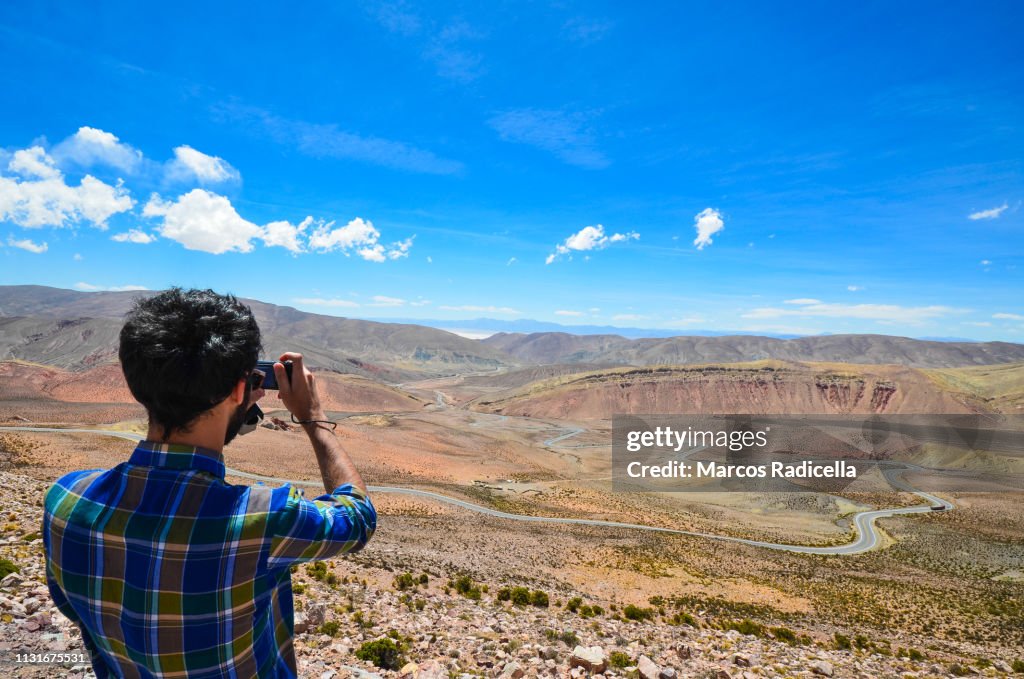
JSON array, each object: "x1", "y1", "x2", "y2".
[{"x1": 0, "y1": 427, "x2": 954, "y2": 555}]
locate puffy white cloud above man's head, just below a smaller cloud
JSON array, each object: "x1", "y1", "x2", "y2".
[{"x1": 142, "y1": 188, "x2": 264, "y2": 255}]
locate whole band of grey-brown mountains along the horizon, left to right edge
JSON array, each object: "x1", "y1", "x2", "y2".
[{"x1": 0, "y1": 286, "x2": 1024, "y2": 374}]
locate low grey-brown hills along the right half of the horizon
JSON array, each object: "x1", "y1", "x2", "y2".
[{"x1": 482, "y1": 333, "x2": 1024, "y2": 368}]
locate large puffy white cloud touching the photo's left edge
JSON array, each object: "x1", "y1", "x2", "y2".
[{"x1": 0, "y1": 146, "x2": 134, "y2": 229}]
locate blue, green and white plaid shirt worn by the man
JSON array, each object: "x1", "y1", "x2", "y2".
[{"x1": 43, "y1": 441, "x2": 377, "y2": 678}]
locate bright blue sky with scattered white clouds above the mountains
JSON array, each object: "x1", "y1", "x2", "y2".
[{"x1": 0, "y1": 2, "x2": 1024, "y2": 341}]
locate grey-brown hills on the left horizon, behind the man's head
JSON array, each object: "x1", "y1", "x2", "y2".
[{"x1": 0, "y1": 286, "x2": 512, "y2": 374}]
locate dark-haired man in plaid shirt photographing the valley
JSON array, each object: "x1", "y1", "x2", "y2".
[{"x1": 43, "y1": 288, "x2": 377, "y2": 678}]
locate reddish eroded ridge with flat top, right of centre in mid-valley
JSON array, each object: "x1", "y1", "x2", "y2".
[{"x1": 471, "y1": 360, "x2": 988, "y2": 420}]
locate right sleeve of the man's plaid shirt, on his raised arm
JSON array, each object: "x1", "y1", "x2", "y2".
[{"x1": 267, "y1": 483, "x2": 377, "y2": 568}]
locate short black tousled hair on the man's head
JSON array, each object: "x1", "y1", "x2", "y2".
[{"x1": 118, "y1": 288, "x2": 261, "y2": 440}]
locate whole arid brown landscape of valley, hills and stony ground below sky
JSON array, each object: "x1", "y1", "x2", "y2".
[{"x1": 0, "y1": 288, "x2": 1024, "y2": 679}]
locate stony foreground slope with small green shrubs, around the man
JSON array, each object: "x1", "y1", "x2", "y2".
[{"x1": 0, "y1": 472, "x2": 1024, "y2": 679}]
